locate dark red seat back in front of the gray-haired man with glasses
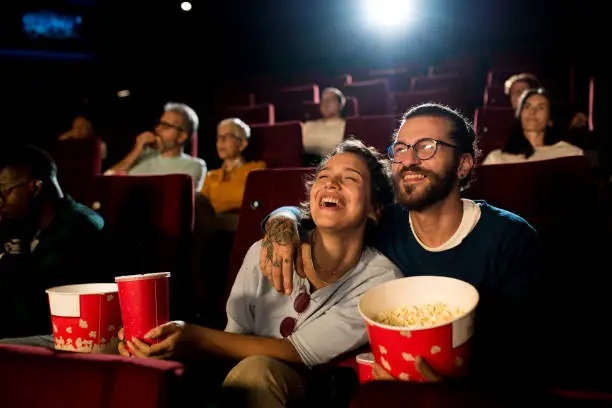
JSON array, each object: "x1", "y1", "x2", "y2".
[{"x1": 92, "y1": 174, "x2": 194, "y2": 318}]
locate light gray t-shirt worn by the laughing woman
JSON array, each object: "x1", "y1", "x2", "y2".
[{"x1": 225, "y1": 241, "x2": 403, "y2": 366}]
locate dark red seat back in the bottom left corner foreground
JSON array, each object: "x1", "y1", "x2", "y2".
[{"x1": 0, "y1": 345, "x2": 183, "y2": 408}]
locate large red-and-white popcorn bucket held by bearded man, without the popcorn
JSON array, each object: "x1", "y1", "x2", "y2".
[{"x1": 359, "y1": 276, "x2": 479, "y2": 381}]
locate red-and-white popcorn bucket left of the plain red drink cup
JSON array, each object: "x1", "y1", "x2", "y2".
[{"x1": 46, "y1": 283, "x2": 121, "y2": 353}]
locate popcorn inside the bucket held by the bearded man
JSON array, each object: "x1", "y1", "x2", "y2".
[{"x1": 374, "y1": 303, "x2": 464, "y2": 328}]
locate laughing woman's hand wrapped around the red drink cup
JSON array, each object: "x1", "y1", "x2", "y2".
[{"x1": 118, "y1": 320, "x2": 193, "y2": 359}]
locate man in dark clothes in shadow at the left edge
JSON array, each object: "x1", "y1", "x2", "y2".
[{"x1": 0, "y1": 147, "x2": 104, "y2": 340}]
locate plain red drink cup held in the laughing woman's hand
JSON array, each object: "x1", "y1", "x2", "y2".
[{"x1": 115, "y1": 272, "x2": 170, "y2": 344}]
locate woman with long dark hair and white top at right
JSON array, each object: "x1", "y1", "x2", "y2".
[{"x1": 482, "y1": 88, "x2": 584, "y2": 165}]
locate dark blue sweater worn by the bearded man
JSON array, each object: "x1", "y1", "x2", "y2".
[{"x1": 374, "y1": 201, "x2": 538, "y2": 300}]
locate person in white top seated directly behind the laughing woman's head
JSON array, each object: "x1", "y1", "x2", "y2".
[{"x1": 302, "y1": 88, "x2": 346, "y2": 165}]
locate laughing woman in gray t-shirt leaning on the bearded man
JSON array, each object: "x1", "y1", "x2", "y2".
[{"x1": 119, "y1": 140, "x2": 401, "y2": 408}]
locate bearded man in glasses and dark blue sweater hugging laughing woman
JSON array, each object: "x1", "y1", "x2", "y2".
[{"x1": 259, "y1": 104, "x2": 537, "y2": 385}]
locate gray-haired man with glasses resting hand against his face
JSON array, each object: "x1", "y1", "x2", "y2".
[{"x1": 105, "y1": 102, "x2": 206, "y2": 191}]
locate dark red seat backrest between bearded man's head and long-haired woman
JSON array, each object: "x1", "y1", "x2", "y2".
[{"x1": 474, "y1": 108, "x2": 515, "y2": 159}]
